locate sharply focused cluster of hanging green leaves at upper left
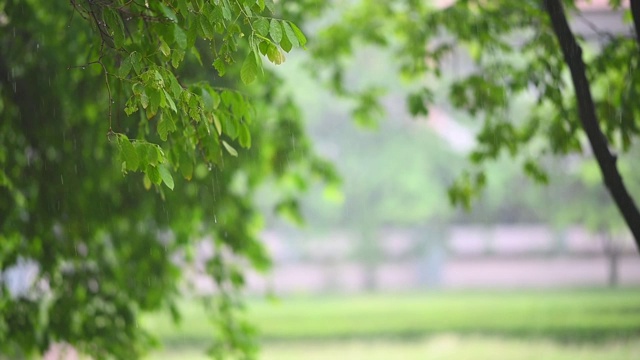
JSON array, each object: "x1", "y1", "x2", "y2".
[{"x1": 72, "y1": 0, "x2": 307, "y2": 189}]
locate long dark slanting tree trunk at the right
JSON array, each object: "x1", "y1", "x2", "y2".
[{"x1": 544, "y1": 0, "x2": 640, "y2": 251}]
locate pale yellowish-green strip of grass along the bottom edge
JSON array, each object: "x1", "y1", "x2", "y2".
[{"x1": 149, "y1": 334, "x2": 640, "y2": 360}]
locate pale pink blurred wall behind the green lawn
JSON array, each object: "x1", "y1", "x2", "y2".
[{"x1": 241, "y1": 225, "x2": 640, "y2": 294}]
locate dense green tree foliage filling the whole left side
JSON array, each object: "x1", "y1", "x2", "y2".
[{"x1": 0, "y1": 0, "x2": 336, "y2": 359}]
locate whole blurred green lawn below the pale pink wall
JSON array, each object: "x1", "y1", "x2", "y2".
[{"x1": 143, "y1": 289, "x2": 640, "y2": 359}]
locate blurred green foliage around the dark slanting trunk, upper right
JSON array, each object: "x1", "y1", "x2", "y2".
[{"x1": 304, "y1": 0, "x2": 640, "y2": 248}]
